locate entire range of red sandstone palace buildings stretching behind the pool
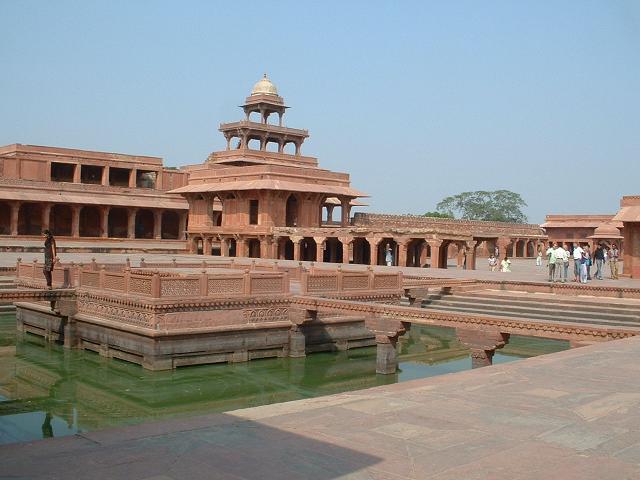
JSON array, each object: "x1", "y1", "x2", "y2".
[{"x1": 5, "y1": 75, "x2": 640, "y2": 276}]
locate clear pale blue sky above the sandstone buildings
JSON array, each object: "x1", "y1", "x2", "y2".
[{"x1": 0, "y1": 0, "x2": 640, "y2": 222}]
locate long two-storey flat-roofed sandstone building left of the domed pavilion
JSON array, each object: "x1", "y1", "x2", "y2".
[{"x1": 0, "y1": 144, "x2": 188, "y2": 240}]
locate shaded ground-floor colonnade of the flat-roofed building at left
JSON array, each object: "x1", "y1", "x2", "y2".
[{"x1": 0, "y1": 202, "x2": 187, "y2": 240}]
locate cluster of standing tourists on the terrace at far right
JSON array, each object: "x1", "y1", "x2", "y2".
[{"x1": 536, "y1": 242, "x2": 620, "y2": 283}]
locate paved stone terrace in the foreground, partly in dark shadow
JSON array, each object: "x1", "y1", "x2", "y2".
[{"x1": 0, "y1": 337, "x2": 640, "y2": 480}]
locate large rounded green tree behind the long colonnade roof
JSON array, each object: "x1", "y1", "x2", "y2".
[{"x1": 436, "y1": 190, "x2": 527, "y2": 223}]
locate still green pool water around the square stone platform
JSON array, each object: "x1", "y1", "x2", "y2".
[{"x1": 0, "y1": 315, "x2": 569, "y2": 444}]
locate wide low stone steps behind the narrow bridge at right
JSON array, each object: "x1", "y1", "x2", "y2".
[{"x1": 408, "y1": 291, "x2": 640, "y2": 328}]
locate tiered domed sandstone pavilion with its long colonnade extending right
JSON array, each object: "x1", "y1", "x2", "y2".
[{"x1": 171, "y1": 75, "x2": 545, "y2": 268}]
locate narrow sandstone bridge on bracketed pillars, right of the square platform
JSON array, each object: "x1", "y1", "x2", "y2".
[{"x1": 291, "y1": 296, "x2": 640, "y2": 373}]
